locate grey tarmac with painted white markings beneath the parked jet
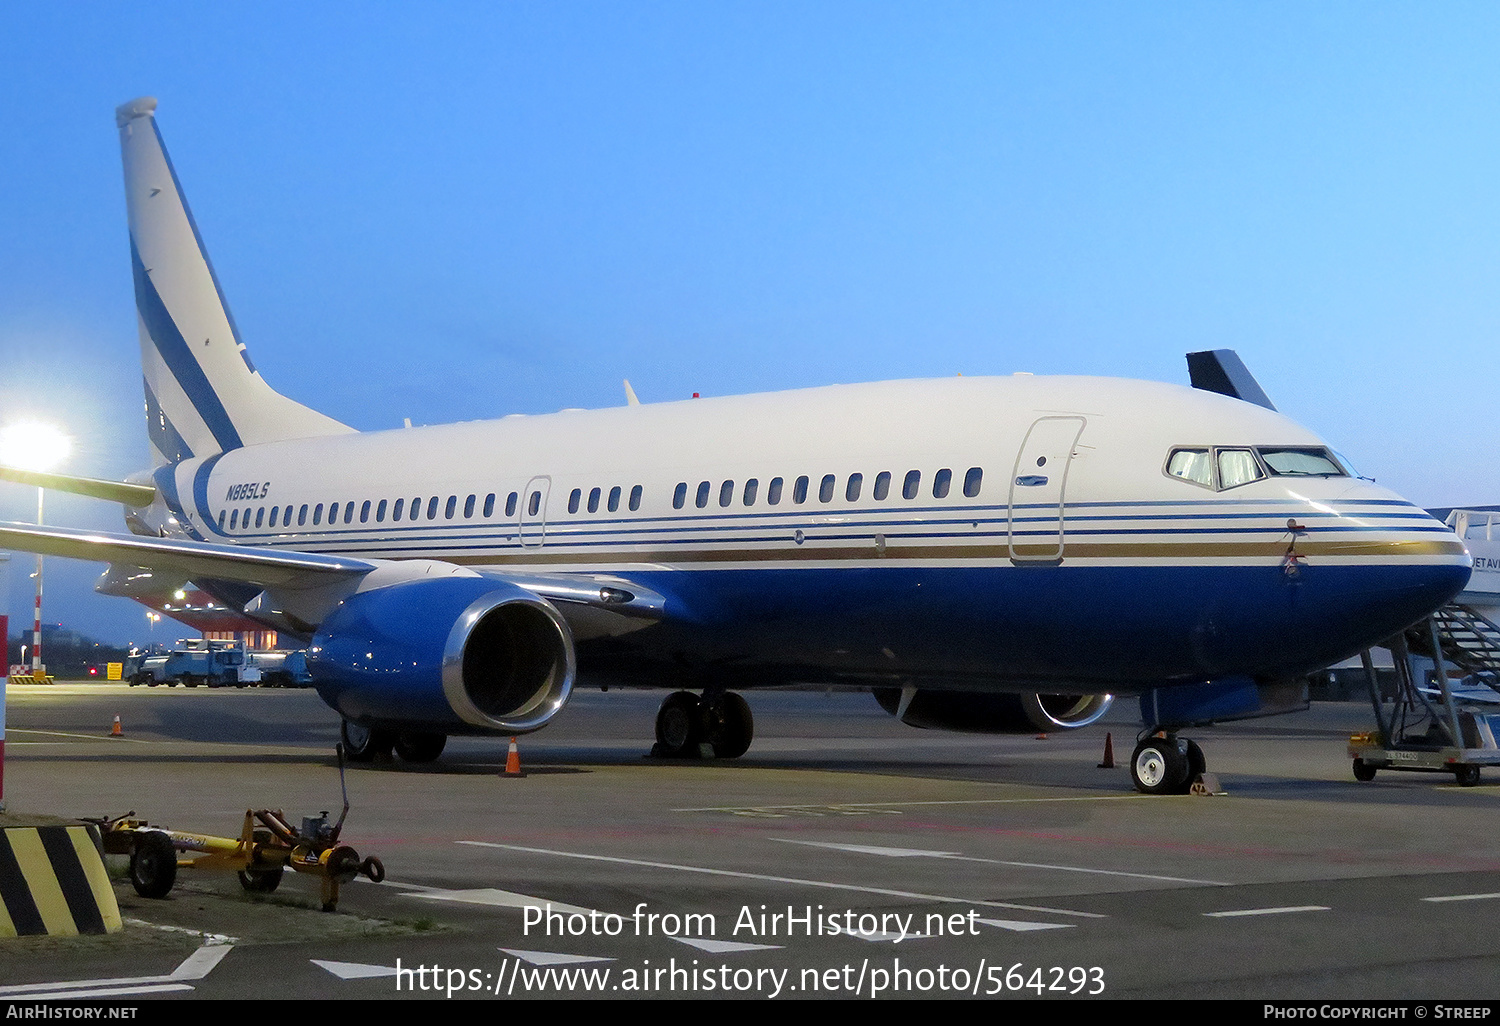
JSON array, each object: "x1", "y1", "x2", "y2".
[{"x1": 0, "y1": 683, "x2": 1500, "y2": 1001}]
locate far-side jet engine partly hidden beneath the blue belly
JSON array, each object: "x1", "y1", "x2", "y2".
[{"x1": 875, "y1": 687, "x2": 1115, "y2": 734}]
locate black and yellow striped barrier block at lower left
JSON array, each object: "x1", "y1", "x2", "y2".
[{"x1": 0, "y1": 818, "x2": 120, "y2": 938}]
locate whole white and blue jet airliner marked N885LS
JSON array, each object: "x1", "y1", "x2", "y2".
[{"x1": 0, "y1": 99, "x2": 1470, "y2": 792}]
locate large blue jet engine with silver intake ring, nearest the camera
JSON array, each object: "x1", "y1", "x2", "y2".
[{"x1": 308, "y1": 575, "x2": 576, "y2": 735}]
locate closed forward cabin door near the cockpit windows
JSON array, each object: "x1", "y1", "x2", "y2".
[{"x1": 1008, "y1": 417, "x2": 1085, "y2": 564}]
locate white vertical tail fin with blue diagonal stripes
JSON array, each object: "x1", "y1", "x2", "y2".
[{"x1": 116, "y1": 96, "x2": 353, "y2": 465}]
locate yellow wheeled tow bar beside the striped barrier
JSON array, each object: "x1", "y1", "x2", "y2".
[{"x1": 87, "y1": 744, "x2": 386, "y2": 912}]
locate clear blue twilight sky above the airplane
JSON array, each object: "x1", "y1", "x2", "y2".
[{"x1": 0, "y1": 0, "x2": 1500, "y2": 641}]
